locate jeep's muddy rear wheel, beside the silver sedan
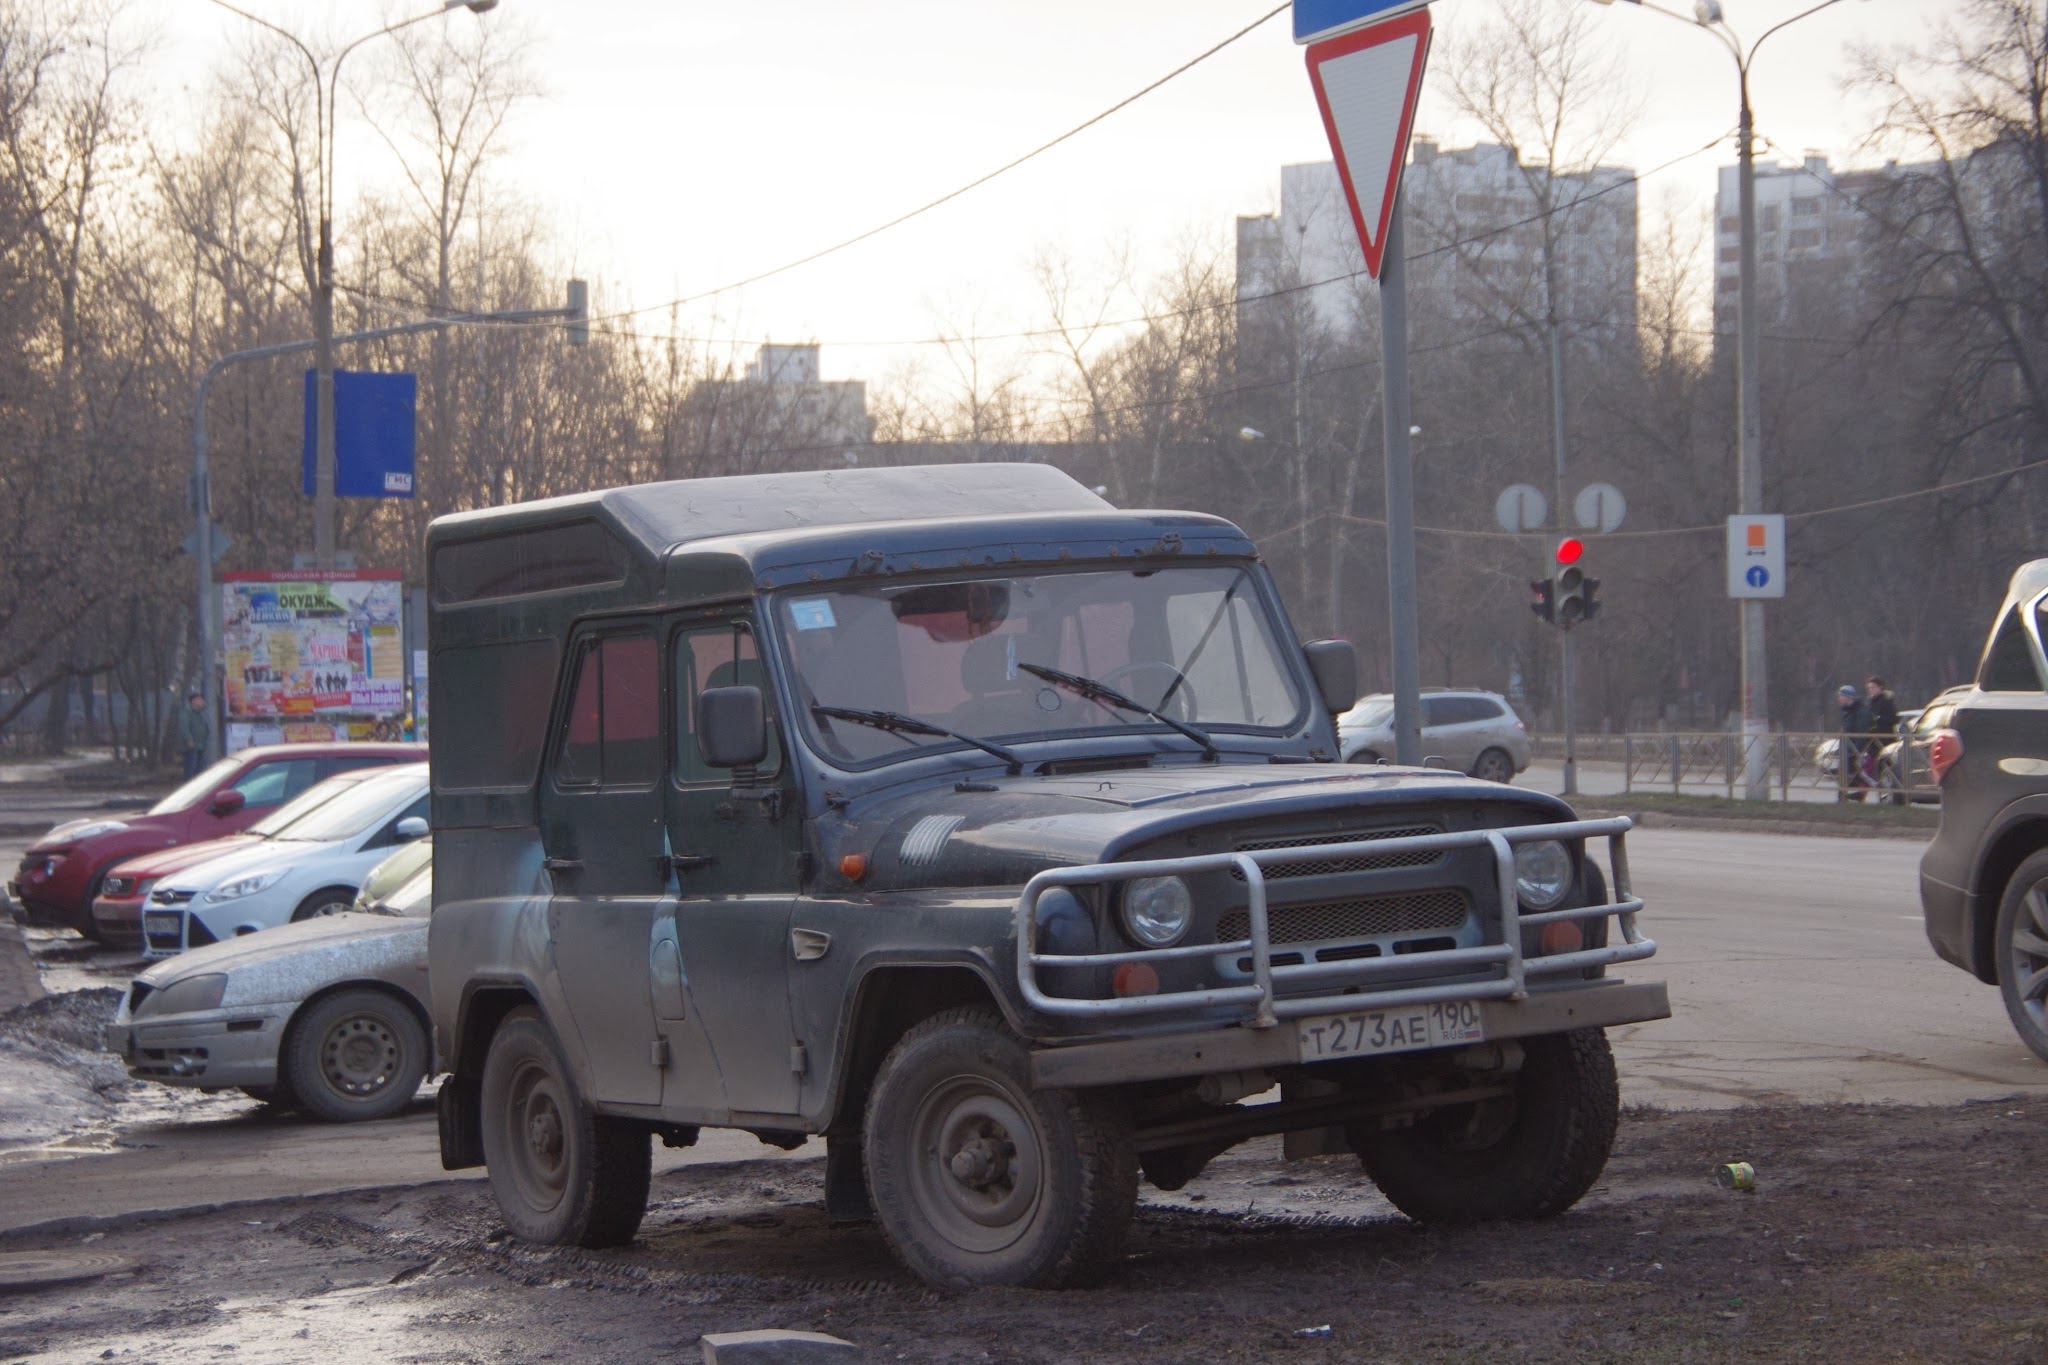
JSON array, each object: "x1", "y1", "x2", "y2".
[{"x1": 483, "y1": 1009, "x2": 653, "y2": 1246}]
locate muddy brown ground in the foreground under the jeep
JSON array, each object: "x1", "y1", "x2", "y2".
[{"x1": 0, "y1": 1101, "x2": 2048, "y2": 1363}]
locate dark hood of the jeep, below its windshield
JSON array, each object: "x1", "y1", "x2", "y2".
[{"x1": 825, "y1": 763, "x2": 1575, "y2": 890}]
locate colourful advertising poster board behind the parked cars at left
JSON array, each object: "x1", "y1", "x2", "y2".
[{"x1": 221, "y1": 569, "x2": 406, "y2": 743}]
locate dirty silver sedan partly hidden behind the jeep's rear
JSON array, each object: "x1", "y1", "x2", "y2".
[{"x1": 106, "y1": 868, "x2": 434, "y2": 1124}]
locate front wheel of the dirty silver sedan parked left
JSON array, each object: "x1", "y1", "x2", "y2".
[{"x1": 282, "y1": 990, "x2": 426, "y2": 1124}]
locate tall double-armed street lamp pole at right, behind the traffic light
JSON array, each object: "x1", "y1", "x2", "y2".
[{"x1": 1593, "y1": 0, "x2": 1867, "y2": 800}]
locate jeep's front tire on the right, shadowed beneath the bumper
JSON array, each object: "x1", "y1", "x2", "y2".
[{"x1": 1352, "y1": 1029, "x2": 1622, "y2": 1224}]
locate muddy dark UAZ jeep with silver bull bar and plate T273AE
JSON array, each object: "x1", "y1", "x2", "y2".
[{"x1": 428, "y1": 465, "x2": 1669, "y2": 1285}]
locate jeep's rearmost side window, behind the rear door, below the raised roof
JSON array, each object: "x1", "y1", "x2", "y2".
[{"x1": 432, "y1": 641, "x2": 557, "y2": 792}]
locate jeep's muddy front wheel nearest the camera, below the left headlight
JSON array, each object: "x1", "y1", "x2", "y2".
[{"x1": 864, "y1": 1009, "x2": 1139, "y2": 1289}]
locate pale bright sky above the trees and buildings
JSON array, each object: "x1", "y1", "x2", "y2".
[{"x1": 159, "y1": 0, "x2": 1948, "y2": 381}]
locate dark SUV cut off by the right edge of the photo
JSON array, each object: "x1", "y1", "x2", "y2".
[{"x1": 1921, "y1": 559, "x2": 2048, "y2": 1060}]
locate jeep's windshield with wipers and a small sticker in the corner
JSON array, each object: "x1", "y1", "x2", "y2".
[{"x1": 774, "y1": 565, "x2": 1303, "y2": 767}]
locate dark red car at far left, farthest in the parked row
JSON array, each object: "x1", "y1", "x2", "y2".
[{"x1": 8, "y1": 743, "x2": 426, "y2": 939}]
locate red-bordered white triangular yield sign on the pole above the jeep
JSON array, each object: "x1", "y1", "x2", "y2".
[{"x1": 1309, "y1": 10, "x2": 1430, "y2": 280}]
